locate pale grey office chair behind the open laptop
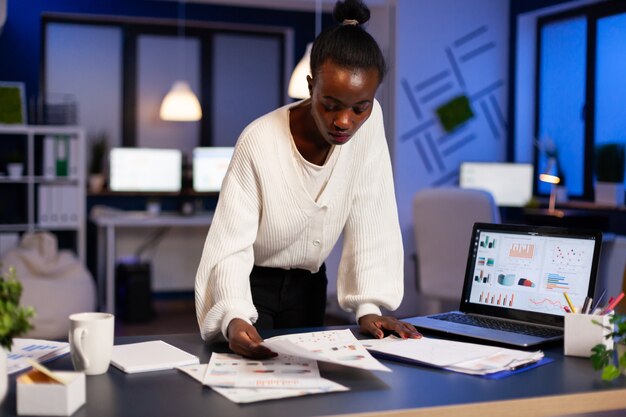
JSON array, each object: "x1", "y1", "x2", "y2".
[{"x1": 413, "y1": 187, "x2": 500, "y2": 314}]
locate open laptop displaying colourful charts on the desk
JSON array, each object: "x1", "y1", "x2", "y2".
[{"x1": 405, "y1": 223, "x2": 602, "y2": 347}]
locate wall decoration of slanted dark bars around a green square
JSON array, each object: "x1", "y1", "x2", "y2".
[{"x1": 399, "y1": 25, "x2": 507, "y2": 186}]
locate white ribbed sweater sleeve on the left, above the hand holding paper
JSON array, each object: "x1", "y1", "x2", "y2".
[{"x1": 195, "y1": 138, "x2": 260, "y2": 340}]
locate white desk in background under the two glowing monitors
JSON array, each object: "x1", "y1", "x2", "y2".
[{"x1": 91, "y1": 210, "x2": 213, "y2": 313}]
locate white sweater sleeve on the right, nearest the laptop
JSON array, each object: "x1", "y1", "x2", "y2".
[{"x1": 337, "y1": 103, "x2": 404, "y2": 321}]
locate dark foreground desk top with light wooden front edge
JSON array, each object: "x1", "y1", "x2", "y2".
[{"x1": 0, "y1": 328, "x2": 626, "y2": 417}]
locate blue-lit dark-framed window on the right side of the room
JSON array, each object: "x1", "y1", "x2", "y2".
[{"x1": 535, "y1": 3, "x2": 626, "y2": 199}]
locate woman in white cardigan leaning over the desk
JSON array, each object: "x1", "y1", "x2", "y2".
[{"x1": 196, "y1": 0, "x2": 419, "y2": 358}]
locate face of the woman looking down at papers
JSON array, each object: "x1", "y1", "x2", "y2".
[{"x1": 308, "y1": 61, "x2": 379, "y2": 145}]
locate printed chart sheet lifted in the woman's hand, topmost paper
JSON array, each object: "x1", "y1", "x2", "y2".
[{"x1": 263, "y1": 329, "x2": 391, "y2": 372}]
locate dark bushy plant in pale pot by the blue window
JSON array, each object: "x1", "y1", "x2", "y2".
[{"x1": 594, "y1": 143, "x2": 624, "y2": 206}]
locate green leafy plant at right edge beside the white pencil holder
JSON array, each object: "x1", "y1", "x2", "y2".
[{"x1": 591, "y1": 314, "x2": 626, "y2": 381}]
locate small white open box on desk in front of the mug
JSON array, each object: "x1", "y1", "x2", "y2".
[{"x1": 17, "y1": 371, "x2": 86, "y2": 416}]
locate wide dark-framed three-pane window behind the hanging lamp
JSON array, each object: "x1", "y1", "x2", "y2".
[{"x1": 41, "y1": 15, "x2": 292, "y2": 157}]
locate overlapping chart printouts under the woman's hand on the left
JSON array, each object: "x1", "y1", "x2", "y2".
[{"x1": 178, "y1": 330, "x2": 390, "y2": 403}]
